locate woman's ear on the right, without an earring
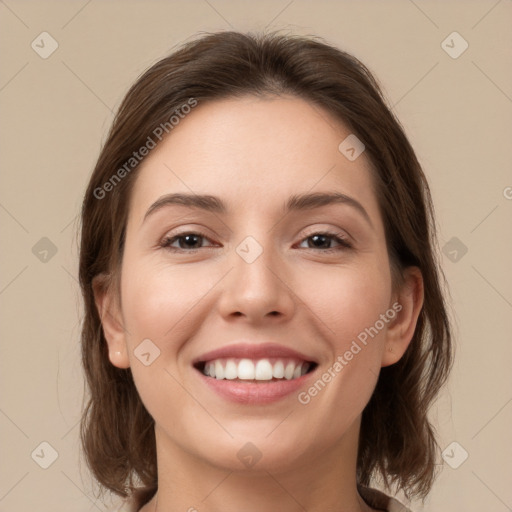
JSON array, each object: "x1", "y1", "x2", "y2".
[{"x1": 381, "y1": 266, "x2": 424, "y2": 366}]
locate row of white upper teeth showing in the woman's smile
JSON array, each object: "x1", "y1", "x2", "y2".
[{"x1": 203, "y1": 359, "x2": 309, "y2": 380}]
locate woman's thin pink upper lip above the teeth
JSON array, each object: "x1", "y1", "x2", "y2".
[{"x1": 192, "y1": 343, "x2": 316, "y2": 365}]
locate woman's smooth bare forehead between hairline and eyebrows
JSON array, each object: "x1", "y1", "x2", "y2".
[{"x1": 126, "y1": 96, "x2": 377, "y2": 222}]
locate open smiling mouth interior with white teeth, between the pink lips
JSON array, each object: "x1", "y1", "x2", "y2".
[{"x1": 194, "y1": 357, "x2": 317, "y2": 383}]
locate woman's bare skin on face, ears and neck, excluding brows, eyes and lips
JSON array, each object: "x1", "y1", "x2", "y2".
[{"x1": 94, "y1": 96, "x2": 423, "y2": 512}]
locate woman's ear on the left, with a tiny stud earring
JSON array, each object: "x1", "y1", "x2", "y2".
[{"x1": 92, "y1": 273, "x2": 130, "y2": 368}]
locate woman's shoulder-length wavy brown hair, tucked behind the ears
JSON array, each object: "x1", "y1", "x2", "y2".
[{"x1": 79, "y1": 32, "x2": 452, "y2": 506}]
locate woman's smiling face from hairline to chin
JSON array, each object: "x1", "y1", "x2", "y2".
[{"x1": 99, "y1": 97, "x2": 416, "y2": 476}]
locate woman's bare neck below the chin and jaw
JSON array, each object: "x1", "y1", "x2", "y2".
[{"x1": 140, "y1": 421, "x2": 374, "y2": 512}]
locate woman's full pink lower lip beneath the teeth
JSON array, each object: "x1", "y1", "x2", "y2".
[{"x1": 196, "y1": 370, "x2": 315, "y2": 405}]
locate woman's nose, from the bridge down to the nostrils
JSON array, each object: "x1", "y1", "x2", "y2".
[{"x1": 218, "y1": 237, "x2": 297, "y2": 324}]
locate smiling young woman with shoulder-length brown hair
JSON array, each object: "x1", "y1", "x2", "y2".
[{"x1": 80, "y1": 32, "x2": 452, "y2": 512}]
